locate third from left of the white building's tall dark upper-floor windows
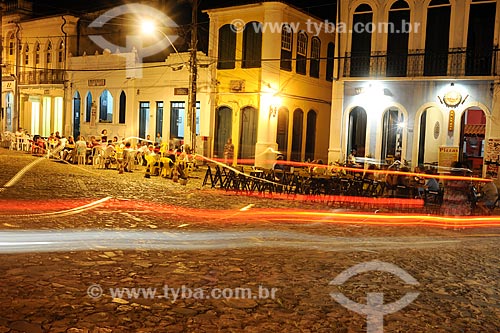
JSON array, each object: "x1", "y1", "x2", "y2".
[{"x1": 424, "y1": 0, "x2": 451, "y2": 76}]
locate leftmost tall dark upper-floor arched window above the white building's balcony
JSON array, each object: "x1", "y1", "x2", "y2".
[{"x1": 350, "y1": 4, "x2": 373, "y2": 77}]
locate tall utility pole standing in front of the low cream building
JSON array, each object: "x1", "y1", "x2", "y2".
[{"x1": 188, "y1": 0, "x2": 198, "y2": 153}]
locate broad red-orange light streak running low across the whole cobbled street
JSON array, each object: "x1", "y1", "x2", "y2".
[{"x1": 0, "y1": 197, "x2": 500, "y2": 228}]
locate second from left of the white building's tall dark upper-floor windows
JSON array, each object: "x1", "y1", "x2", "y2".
[{"x1": 386, "y1": 0, "x2": 410, "y2": 76}]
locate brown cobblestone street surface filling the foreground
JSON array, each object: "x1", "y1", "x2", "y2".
[{"x1": 0, "y1": 149, "x2": 500, "y2": 333}]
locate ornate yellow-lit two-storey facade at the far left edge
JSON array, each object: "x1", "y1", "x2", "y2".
[{"x1": 2, "y1": 1, "x2": 78, "y2": 136}]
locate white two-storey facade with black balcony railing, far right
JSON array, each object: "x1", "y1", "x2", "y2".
[{"x1": 329, "y1": 0, "x2": 500, "y2": 173}]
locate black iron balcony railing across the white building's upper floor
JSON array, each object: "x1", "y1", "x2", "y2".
[{"x1": 343, "y1": 48, "x2": 500, "y2": 77}]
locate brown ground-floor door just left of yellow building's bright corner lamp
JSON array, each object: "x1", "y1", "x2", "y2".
[{"x1": 238, "y1": 106, "x2": 257, "y2": 159}]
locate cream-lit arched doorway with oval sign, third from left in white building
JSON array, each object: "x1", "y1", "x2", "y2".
[{"x1": 418, "y1": 107, "x2": 446, "y2": 165}]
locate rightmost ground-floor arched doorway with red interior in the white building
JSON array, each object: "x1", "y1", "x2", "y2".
[{"x1": 459, "y1": 107, "x2": 486, "y2": 175}]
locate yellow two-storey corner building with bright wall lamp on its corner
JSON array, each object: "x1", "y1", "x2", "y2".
[{"x1": 207, "y1": 2, "x2": 334, "y2": 167}]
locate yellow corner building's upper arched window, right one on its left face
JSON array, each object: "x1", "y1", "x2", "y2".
[{"x1": 241, "y1": 21, "x2": 262, "y2": 68}]
